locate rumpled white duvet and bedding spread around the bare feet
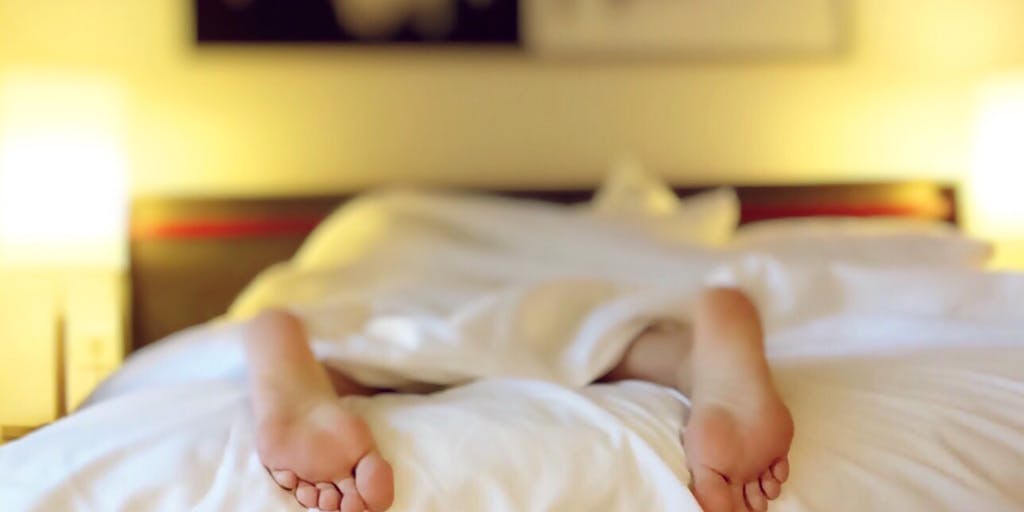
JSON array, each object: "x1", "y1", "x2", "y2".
[{"x1": 0, "y1": 194, "x2": 1024, "y2": 512}]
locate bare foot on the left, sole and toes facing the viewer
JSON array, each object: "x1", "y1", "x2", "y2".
[{"x1": 246, "y1": 311, "x2": 394, "y2": 512}]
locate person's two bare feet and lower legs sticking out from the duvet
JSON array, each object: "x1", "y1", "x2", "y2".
[{"x1": 245, "y1": 288, "x2": 794, "y2": 512}]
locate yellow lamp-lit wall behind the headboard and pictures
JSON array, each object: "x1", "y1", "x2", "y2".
[{"x1": 0, "y1": 0, "x2": 1024, "y2": 194}]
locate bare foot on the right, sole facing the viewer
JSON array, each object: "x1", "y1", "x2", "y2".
[{"x1": 683, "y1": 292, "x2": 794, "y2": 512}]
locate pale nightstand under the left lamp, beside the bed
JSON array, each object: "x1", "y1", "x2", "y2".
[{"x1": 0, "y1": 268, "x2": 127, "y2": 432}]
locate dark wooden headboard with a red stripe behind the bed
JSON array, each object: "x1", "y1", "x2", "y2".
[{"x1": 130, "y1": 183, "x2": 957, "y2": 350}]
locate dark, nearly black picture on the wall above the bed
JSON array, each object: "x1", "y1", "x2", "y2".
[{"x1": 194, "y1": 0, "x2": 520, "y2": 46}]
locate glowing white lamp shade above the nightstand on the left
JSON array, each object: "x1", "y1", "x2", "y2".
[{"x1": 0, "y1": 76, "x2": 127, "y2": 267}]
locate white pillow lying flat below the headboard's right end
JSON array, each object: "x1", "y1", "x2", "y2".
[{"x1": 730, "y1": 217, "x2": 992, "y2": 267}]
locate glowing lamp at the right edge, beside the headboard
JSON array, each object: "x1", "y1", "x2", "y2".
[{"x1": 966, "y1": 74, "x2": 1024, "y2": 268}]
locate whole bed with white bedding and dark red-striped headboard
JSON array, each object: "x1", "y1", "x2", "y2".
[{"x1": 0, "y1": 177, "x2": 1024, "y2": 512}]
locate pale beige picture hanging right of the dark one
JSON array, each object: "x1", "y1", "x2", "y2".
[{"x1": 521, "y1": 0, "x2": 847, "y2": 57}]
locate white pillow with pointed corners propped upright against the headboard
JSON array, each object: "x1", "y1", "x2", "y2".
[{"x1": 589, "y1": 163, "x2": 739, "y2": 246}]
